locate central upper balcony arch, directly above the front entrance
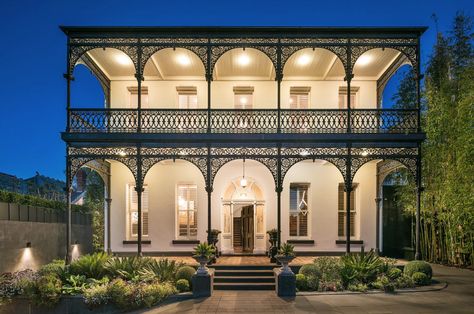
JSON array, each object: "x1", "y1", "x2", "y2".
[{"x1": 211, "y1": 48, "x2": 277, "y2": 110}]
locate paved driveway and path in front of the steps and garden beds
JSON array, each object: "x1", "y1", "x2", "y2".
[{"x1": 141, "y1": 265, "x2": 474, "y2": 314}]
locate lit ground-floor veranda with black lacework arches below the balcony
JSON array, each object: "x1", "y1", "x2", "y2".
[{"x1": 68, "y1": 147, "x2": 419, "y2": 256}]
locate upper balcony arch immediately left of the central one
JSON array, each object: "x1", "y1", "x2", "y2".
[{"x1": 142, "y1": 48, "x2": 207, "y2": 109}]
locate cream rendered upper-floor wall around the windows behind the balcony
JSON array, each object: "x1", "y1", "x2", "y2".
[{"x1": 111, "y1": 80, "x2": 377, "y2": 109}]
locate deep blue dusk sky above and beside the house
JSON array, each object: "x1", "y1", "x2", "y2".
[{"x1": 0, "y1": 0, "x2": 474, "y2": 180}]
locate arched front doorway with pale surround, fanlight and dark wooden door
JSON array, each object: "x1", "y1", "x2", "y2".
[{"x1": 222, "y1": 177, "x2": 265, "y2": 254}]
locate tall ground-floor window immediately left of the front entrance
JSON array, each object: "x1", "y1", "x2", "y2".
[{"x1": 176, "y1": 184, "x2": 197, "y2": 239}]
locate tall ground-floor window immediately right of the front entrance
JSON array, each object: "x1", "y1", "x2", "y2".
[{"x1": 290, "y1": 183, "x2": 309, "y2": 237}]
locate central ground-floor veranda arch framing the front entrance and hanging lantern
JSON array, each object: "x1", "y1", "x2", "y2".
[{"x1": 212, "y1": 159, "x2": 276, "y2": 254}]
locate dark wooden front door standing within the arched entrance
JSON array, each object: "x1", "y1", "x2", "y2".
[{"x1": 233, "y1": 205, "x2": 254, "y2": 253}]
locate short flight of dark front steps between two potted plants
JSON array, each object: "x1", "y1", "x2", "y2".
[{"x1": 209, "y1": 264, "x2": 277, "y2": 290}]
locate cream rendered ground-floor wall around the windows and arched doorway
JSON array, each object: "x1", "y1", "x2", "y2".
[{"x1": 111, "y1": 160, "x2": 376, "y2": 253}]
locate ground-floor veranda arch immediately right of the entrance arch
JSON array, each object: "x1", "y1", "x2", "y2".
[{"x1": 281, "y1": 159, "x2": 345, "y2": 251}]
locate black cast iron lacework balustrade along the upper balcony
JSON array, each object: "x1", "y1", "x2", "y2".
[{"x1": 69, "y1": 109, "x2": 418, "y2": 134}]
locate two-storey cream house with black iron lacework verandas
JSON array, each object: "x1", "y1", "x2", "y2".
[{"x1": 61, "y1": 27, "x2": 425, "y2": 262}]
